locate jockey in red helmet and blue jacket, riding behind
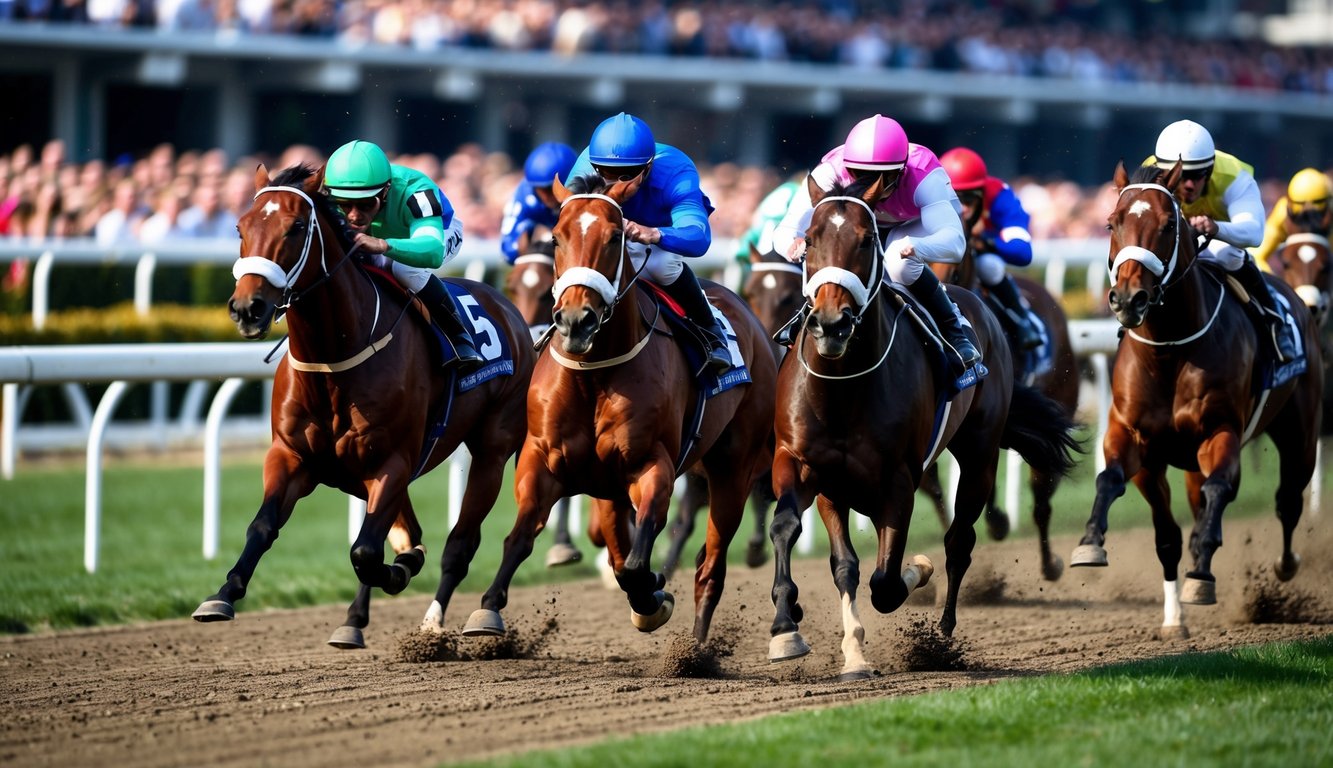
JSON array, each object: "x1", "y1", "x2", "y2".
[{"x1": 940, "y1": 147, "x2": 1041, "y2": 349}]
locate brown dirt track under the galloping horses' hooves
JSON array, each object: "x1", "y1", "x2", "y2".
[{"x1": 0, "y1": 509, "x2": 1333, "y2": 768}]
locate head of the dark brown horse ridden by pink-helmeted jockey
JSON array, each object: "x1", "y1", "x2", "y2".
[{"x1": 805, "y1": 177, "x2": 889, "y2": 359}]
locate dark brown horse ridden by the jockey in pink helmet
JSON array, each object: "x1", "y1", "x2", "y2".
[{"x1": 769, "y1": 177, "x2": 1076, "y2": 680}]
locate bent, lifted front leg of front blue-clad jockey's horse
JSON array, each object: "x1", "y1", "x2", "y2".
[{"x1": 615, "y1": 453, "x2": 676, "y2": 632}]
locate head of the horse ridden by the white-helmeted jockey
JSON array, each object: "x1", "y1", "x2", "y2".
[{"x1": 1106, "y1": 161, "x2": 1194, "y2": 328}]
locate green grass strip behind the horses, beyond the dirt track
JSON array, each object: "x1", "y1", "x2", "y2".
[{"x1": 0, "y1": 432, "x2": 1311, "y2": 633}]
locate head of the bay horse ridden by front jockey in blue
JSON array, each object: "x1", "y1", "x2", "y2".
[{"x1": 552, "y1": 173, "x2": 644, "y2": 355}]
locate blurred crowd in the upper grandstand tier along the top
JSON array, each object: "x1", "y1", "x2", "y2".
[{"x1": 0, "y1": 0, "x2": 1333, "y2": 93}]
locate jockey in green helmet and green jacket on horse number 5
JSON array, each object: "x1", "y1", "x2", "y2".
[{"x1": 324, "y1": 140, "x2": 484, "y2": 369}]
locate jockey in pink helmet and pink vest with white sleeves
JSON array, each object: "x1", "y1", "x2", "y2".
[{"x1": 773, "y1": 115, "x2": 981, "y2": 373}]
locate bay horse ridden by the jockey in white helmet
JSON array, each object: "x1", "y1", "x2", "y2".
[{"x1": 1070, "y1": 163, "x2": 1324, "y2": 639}]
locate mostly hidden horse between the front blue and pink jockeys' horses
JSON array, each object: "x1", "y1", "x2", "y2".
[{"x1": 663, "y1": 243, "x2": 804, "y2": 579}]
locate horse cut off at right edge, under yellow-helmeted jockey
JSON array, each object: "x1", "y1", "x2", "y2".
[{"x1": 1269, "y1": 209, "x2": 1333, "y2": 435}]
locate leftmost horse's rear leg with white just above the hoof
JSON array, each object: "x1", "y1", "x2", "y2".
[{"x1": 421, "y1": 445, "x2": 508, "y2": 632}]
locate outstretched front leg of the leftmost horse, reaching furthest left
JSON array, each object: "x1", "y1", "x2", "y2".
[{"x1": 192, "y1": 444, "x2": 315, "y2": 621}]
